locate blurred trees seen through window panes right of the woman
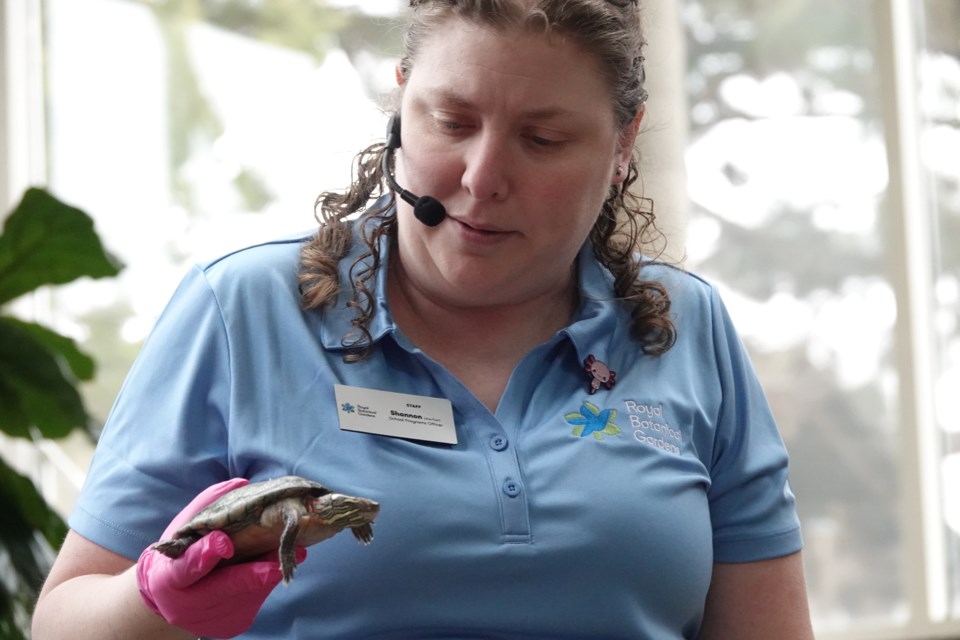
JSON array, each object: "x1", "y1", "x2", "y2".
[{"x1": 683, "y1": 0, "x2": 960, "y2": 637}]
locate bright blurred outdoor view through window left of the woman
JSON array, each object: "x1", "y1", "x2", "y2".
[{"x1": 45, "y1": 0, "x2": 399, "y2": 436}]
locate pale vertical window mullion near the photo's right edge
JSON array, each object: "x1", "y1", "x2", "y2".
[{"x1": 875, "y1": 0, "x2": 948, "y2": 626}]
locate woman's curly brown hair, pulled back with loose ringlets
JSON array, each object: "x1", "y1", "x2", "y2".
[{"x1": 299, "y1": 0, "x2": 676, "y2": 362}]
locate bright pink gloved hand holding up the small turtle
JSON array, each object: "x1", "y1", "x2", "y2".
[{"x1": 137, "y1": 478, "x2": 307, "y2": 638}]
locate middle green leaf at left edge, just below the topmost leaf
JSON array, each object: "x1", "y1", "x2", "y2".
[{"x1": 0, "y1": 317, "x2": 87, "y2": 438}]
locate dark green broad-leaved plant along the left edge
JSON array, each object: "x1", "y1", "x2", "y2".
[{"x1": 0, "y1": 189, "x2": 120, "y2": 640}]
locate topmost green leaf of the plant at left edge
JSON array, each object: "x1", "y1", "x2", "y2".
[{"x1": 0, "y1": 188, "x2": 121, "y2": 304}]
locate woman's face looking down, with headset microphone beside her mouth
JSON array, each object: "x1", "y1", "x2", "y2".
[{"x1": 397, "y1": 18, "x2": 639, "y2": 307}]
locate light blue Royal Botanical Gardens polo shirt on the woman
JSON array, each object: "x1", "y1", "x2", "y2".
[{"x1": 70, "y1": 214, "x2": 801, "y2": 640}]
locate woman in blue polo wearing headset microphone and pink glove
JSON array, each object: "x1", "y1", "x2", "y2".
[{"x1": 34, "y1": 0, "x2": 812, "y2": 640}]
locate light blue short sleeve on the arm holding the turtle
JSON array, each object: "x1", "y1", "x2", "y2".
[{"x1": 69, "y1": 268, "x2": 230, "y2": 559}]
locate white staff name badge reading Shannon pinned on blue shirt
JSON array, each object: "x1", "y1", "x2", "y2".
[{"x1": 333, "y1": 384, "x2": 457, "y2": 444}]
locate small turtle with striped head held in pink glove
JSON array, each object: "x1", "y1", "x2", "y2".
[{"x1": 151, "y1": 476, "x2": 380, "y2": 584}]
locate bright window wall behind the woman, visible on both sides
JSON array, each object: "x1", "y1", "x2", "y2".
[{"x1": 0, "y1": 0, "x2": 960, "y2": 640}]
